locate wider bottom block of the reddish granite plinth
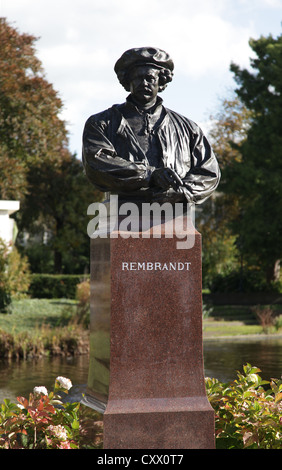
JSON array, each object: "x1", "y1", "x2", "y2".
[{"x1": 104, "y1": 397, "x2": 215, "y2": 449}]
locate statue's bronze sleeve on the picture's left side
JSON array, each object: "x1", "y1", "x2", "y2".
[{"x1": 82, "y1": 116, "x2": 152, "y2": 193}]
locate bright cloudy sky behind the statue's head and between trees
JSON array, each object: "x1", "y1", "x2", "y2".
[{"x1": 0, "y1": 0, "x2": 282, "y2": 156}]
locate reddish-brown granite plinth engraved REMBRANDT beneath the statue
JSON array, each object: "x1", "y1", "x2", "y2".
[{"x1": 85, "y1": 211, "x2": 214, "y2": 449}]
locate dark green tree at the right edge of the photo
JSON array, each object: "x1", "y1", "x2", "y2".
[{"x1": 220, "y1": 35, "x2": 282, "y2": 283}]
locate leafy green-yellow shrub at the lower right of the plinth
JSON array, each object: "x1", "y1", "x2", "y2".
[{"x1": 206, "y1": 364, "x2": 282, "y2": 449}]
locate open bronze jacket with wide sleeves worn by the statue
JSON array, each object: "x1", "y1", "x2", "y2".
[{"x1": 82, "y1": 98, "x2": 220, "y2": 204}]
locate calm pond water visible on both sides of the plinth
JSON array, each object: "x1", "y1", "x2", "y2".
[{"x1": 0, "y1": 336, "x2": 282, "y2": 403}]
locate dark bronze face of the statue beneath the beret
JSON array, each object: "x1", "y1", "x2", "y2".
[{"x1": 130, "y1": 65, "x2": 159, "y2": 107}]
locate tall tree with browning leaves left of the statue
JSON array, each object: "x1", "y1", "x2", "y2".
[{"x1": 0, "y1": 18, "x2": 100, "y2": 273}]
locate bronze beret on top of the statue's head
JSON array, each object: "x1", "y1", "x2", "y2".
[{"x1": 114, "y1": 47, "x2": 174, "y2": 78}]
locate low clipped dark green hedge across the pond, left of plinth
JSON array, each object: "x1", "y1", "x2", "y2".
[{"x1": 28, "y1": 274, "x2": 88, "y2": 299}]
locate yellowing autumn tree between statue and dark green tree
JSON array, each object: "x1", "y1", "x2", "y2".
[{"x1": 197, "y1": 96, "x2": 251, "y2": 287}]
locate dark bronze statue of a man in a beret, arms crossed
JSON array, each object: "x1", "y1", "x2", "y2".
[{"x1": 83, "y1": 47, "x2": 220, "y2": 204}]
